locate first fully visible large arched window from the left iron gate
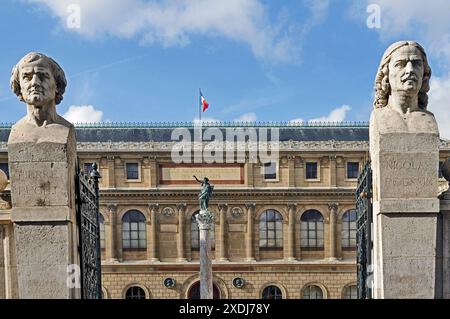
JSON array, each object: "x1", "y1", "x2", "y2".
[{"x1": 122, "y1": 210, "x2": 147, "y2": 249}]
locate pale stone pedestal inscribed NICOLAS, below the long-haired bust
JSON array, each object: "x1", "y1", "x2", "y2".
[{"x1": 370, "y1": 107, "x2": 439, "y2": 298}]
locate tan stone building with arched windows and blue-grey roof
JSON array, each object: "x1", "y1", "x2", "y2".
[{"x1": 0, "y1": 123, "x2": 450, "y2": 299}]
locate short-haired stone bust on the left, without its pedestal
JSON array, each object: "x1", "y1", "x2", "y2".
[{"x1": 10, "y1": 52, "x2": 73, "y2": 140}]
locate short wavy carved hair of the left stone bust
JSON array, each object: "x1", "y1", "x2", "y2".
[{"x1": 10, "y1": 52, "x2": 67, "y2": 105}]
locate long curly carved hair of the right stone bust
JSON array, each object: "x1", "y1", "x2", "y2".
[{"x1": 373, "y1": 41, "x2": 431, "y2": 110}]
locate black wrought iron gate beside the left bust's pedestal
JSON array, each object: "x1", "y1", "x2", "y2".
[{"x1": 75, "y1": 163, "x2": 102, "y2": 299}]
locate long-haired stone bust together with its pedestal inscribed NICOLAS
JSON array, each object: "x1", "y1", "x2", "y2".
[{"x1": 369, "y1": 41, "x2": 440, "y2": 298}]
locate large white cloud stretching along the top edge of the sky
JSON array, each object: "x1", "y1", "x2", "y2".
[{"x1": 22, "y1": 0, "x2": 329, "y2": 62}]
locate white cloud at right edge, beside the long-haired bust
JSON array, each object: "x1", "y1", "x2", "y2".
[{"x1": 428, "y1": 73, "x2": 450, "y2": 139}]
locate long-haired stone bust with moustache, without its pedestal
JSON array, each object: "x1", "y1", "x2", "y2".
[{"x1": 371, "y1": 41, "x2": 438, "y2": 132}]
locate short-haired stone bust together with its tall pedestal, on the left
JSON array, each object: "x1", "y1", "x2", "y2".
[{"x1": 8, "y1": 52, "x2": 81, "y2": 299}]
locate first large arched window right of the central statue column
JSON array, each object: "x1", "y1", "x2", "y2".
[{"x1": 259, "y1": 209, "x2": 283, "y2": 248}]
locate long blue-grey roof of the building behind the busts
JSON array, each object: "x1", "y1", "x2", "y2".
[{"x1": 0, "y1": 122, "x2": 369, "y2": 143}]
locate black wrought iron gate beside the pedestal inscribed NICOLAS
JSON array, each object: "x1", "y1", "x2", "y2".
[{"x1": 356, "y1": 162, "x2": 373, "y2": 299}]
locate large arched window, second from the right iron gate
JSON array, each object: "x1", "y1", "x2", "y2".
[{"x1": 300, "y1": 209, "x2": 323, "y2": 250}]
